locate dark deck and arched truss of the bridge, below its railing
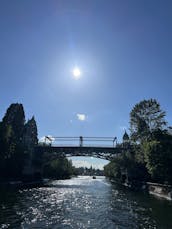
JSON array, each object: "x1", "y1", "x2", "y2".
[{"x1": 37, "y1": 146, "x2": 122, "y2": 160}]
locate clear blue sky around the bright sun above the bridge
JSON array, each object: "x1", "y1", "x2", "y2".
[{"x1": 0, "y1": 0, "x2": 172, "y2": 166}]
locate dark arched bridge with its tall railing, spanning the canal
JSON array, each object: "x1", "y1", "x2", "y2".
[{"x1": 37, "y1": 136, "x2": 130, "y2": 160}]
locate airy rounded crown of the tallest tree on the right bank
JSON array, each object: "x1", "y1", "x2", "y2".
[{"x1": 130, "y1": 99, "x2": 167, "y2": 142}]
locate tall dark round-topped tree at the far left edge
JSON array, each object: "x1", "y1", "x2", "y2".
[{"x1": 0, "y1": 103, "x2": 25, "y2": 179}]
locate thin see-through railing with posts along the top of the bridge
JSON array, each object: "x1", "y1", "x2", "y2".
[{"x1": 39, "y1": 136, "x2": 117, "y2": 147}]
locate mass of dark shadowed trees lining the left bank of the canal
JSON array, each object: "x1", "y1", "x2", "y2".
[{"x1": 0, "y1": 103, "x2": 74, "y2": 182}]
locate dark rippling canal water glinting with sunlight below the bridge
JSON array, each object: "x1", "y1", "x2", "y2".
[{"x1": 0, "y1": 176, "x2": 172, "y2": 229}]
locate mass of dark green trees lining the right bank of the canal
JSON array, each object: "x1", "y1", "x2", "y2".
[{"x1": 104, "y1": 99, "x2": 172, "y2": 186}]
